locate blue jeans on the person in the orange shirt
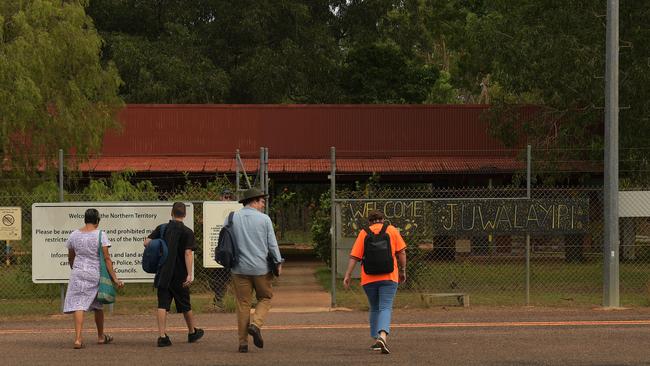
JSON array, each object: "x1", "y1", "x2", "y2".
[{"x1": 363, "y1": 280, "x2": 397, "y2": 338}]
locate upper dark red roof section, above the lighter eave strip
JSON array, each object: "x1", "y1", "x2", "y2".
[{"x1": 97, "y1": 104, "x2": 534, "y2": 159}]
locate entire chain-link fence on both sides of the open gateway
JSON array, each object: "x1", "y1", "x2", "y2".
[{"x1": 0, "y1": 185, "x2": 650, "y2": 316}]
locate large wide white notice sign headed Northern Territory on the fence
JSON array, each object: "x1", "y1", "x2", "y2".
[{"x1": 32, "y1": 202, "x2": 194, "y2": 283}]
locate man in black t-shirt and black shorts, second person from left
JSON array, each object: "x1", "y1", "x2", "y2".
[{"x1": 144, "y1": 202, "x2": 204, "y2": 347}]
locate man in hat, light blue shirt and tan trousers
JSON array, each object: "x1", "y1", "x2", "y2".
[{"x1": 232, "y1": 188, "x2": 282, "y2": 353}]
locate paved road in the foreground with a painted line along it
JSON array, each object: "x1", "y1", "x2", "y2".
[{"x1": 0, "y1": 307, "x2": 650, "y2": 366}]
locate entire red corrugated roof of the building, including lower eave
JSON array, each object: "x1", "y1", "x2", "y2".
[{"x1": 80, "y1": 104, "x2": 534, "y2": 174}]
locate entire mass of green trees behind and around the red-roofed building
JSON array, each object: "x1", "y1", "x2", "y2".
[{"x1": 0, "y1": 0, "x2": 650, "y2": 181}]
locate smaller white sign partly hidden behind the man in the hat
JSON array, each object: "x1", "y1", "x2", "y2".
[{"x1": 203, "y1": 201, "x2": 242, "y2": 268}]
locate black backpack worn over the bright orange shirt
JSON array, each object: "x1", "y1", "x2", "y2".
[{"x1": 361, "y1": 222, "x2": 395, "y2": 274}]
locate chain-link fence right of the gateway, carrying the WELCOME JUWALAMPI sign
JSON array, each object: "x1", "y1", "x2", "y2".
[{"x1": 335, "y1": 187, "x2": 650, "y2": 306}]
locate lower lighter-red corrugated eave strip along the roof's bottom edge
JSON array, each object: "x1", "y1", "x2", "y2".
[{"x1": 80, "y1": 156, "x2": 523, "y2": 174}]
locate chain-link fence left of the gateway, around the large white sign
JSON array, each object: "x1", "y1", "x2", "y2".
[{"x1": 0, "y1": 193, "x2": 235, "y2": 316}]
